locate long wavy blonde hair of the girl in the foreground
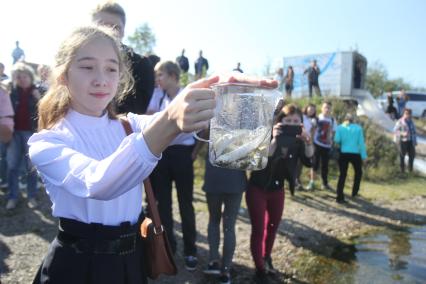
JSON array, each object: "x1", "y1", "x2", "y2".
[{"x1": 38, "y1": 26, "x2": 133, "y2": 131}]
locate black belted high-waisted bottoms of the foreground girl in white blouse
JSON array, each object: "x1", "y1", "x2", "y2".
[{"x1": 33, "y1": 218, "x2": 147, "y2": 284}]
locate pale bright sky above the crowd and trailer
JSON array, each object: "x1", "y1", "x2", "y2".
[{"x1": 0, "y1": 0, "x2": 426, "y2": 87}]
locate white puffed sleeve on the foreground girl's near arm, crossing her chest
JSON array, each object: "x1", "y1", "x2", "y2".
[{"x1": 28, "y1": 127, "x2": 160, "y2": 200}]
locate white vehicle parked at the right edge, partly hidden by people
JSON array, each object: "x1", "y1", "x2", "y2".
[{"x1": 376, "y1": 91, "x2": 426, "y2": 118}]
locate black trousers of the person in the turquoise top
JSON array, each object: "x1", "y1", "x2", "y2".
[{"x1": 336, "y1": 153, "x2": 362, "y2": 201}]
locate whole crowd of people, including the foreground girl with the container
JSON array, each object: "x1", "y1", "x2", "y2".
[{"x1": 0, "y1": 2, "x2": 416, "y2": 283}]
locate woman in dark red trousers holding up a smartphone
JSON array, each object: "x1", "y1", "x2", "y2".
[{"x1": 246, "y1": 104, "x2": 313, "y2": 283}]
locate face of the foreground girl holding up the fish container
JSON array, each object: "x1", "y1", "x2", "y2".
[{"x1": 65, "y1": 38, "x2": 120, "y2": 116}]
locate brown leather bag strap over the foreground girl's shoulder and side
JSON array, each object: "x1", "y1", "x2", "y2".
[{"x1": 119, "y1": 116, "x2": 164, "y2": 235}]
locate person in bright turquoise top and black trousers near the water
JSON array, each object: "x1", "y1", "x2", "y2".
[{"x1": 334, "y1": 114, "x2": 367, "y2": 203}]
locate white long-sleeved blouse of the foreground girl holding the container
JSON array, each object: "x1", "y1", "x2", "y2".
[{"x1": 28, "y1": 110, "x2": 161, "y2": 225}]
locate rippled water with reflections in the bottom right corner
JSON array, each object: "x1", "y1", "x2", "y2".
[{"x1": 311, "y1": 226, "x2": 426, "y2": 284}]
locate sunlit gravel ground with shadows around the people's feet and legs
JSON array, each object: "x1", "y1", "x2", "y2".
[{"x1": 0, "y1": 184, "x2": 426, "y2": 284}]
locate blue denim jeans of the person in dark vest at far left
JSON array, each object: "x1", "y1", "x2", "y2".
[{"x1": 7, "y1": 130, "x2": 37, "y2": 199}]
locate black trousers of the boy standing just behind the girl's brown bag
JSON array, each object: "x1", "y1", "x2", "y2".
[{"x1": 150, "y1": 145, "x2": 197, "y2": 256}]
